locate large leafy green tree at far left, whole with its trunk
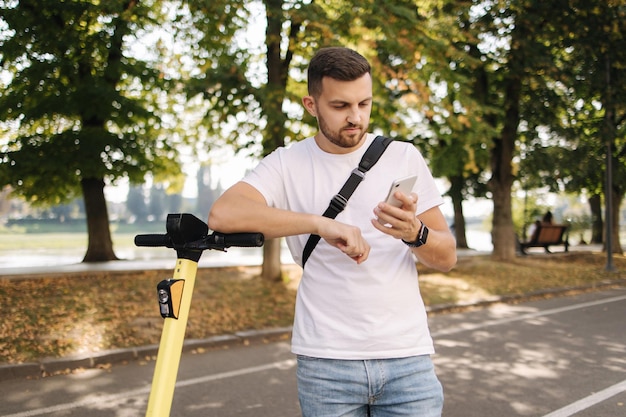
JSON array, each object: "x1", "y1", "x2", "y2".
[{"x1": 0, "y1": 0, "x2": 178, "y2": 262}]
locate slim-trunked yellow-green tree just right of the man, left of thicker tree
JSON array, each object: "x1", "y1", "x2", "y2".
[{"x1": 423, "y1": 1, "x2": 501, "y2": 248}]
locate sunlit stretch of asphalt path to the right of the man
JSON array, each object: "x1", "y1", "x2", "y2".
[{"x1": 431, "y1": 288, "x2": 626, "y2": 417}]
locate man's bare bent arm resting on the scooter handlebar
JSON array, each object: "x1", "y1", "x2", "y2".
[{"x1": 208, "y1": 182, "x2": 370, "y2": 263}]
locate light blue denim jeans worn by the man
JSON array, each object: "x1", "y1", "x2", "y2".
[{"x1": 297, "y1": 356, "x2": 443, "y2": 417}]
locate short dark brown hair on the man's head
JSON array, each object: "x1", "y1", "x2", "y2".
[{"x1": 307, "y1": 46, "x2": 371, "y2": 97}]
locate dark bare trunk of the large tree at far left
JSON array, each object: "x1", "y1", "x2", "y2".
[{"x1": 81, "y1": 178, "x2": 118, "y2": 262}]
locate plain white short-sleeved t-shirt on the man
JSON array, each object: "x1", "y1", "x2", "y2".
[{"x1": 244, "y1": 134, "x2": 443, "y2": 359}]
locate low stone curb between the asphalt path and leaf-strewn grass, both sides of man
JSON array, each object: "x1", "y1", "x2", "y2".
[{"x1": 0, "y1": 279, "x2": 626, "y2": 381}]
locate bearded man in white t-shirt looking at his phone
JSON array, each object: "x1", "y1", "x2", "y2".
[{"x1": 209, "y1": 47, "x2": 456, "y2": 417}]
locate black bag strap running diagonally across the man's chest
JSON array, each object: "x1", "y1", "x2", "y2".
[{"x1": 302, "y1": 136, "x2": 393, "y2": 268}]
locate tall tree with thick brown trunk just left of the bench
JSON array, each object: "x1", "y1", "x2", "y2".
[{"x1": 454, "y1": 0, "x2": 596, "y2": 260}]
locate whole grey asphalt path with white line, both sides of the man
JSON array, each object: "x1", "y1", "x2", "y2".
[{"x1": 0, "y1": 288, "x2": 626, "y2": 417}]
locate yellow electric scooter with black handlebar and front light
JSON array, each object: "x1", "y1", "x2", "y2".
[{"x1": 135, "y1": 213, "x2": 264, "y2": 417}]
